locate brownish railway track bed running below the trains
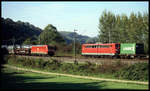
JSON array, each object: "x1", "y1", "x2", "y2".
[{"x1": 14, "y1": 55, "x2": 149, "y2": 64}]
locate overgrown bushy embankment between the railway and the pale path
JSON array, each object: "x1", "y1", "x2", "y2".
[{"x1": 4, "y1": 54, "x2": 148, "y2": 81}]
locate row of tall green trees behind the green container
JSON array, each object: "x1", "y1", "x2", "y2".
[{"x1": 98, "y1": 10, "x2": 149, "y2": 53}]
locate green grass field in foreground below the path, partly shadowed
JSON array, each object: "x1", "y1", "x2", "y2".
[{"x1": 0, "y1": 68, "x2": 148, "y2": 90}]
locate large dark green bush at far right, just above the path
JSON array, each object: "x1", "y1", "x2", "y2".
[{"x1": 115, "y1": 63, "x2": 148, "y2": 81}]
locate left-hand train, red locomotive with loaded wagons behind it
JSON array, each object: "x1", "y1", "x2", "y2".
[{"x1": 2, "y1": 45, "x2": 56, "y2": 56}]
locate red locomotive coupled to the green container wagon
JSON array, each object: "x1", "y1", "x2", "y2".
[{"x1": 82, "y1": 43, "x2": 120, "y2": 56}]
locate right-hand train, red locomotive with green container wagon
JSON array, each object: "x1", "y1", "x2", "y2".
[{"x1": 82, "y1": 43, "x2": 145, "y2": 58}]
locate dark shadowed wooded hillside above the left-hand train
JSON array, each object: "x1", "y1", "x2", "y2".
[{"x1": 1, "y1": 18, "x2": 42, "y2": 44}]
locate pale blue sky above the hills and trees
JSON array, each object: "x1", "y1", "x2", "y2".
[{"x1": 1, "y1": 1, "x2": 149, "y2": 37}]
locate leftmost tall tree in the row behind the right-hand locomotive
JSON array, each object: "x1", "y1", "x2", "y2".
[{"x1": 99, "y1": 10, "x2": 116, "y2": 43}]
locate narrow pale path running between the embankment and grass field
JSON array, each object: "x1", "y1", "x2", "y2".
[{"x1": 4, "y1": 65, "x2": 148, "y2": 84}]
